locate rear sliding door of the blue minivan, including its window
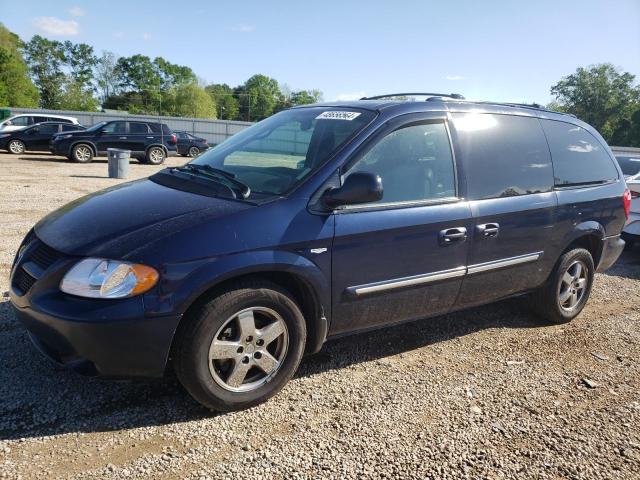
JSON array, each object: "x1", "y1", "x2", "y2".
[{"x1": 452, "y1": 113, "x2": 557, "y2": 307}]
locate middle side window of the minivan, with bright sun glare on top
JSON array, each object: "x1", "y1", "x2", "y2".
[{"x1": 453, "y1": 113, "x2": 553, "y2": 200}]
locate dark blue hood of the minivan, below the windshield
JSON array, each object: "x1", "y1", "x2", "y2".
[{"x1": 34, "y1": 179, "x2": 251, "y2": 258}]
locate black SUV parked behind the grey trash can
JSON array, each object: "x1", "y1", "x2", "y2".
[{"x1": 49, "y1": 120, "x2": 178, "y2": 165}]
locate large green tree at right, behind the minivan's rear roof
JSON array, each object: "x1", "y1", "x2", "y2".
[{"x1": 551, "y1": 63, "x2": 640, "y2": 142}]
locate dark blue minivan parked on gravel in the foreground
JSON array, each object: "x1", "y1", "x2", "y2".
[{"x1": 11, "y1": 94, "x2": 630, "y2": 410}]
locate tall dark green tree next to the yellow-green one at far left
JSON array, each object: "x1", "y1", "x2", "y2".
[{"x1": 24, "y1": 35, "x2": 66, "y2": 109}]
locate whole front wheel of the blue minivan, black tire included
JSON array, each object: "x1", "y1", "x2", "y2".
[{"x1": 173, "y1": 281, "x2": 307, "y2": 411}]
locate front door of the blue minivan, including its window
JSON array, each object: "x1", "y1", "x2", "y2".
[{"x1": 330, "y1": 114, "x2": 472, "y2": 335}]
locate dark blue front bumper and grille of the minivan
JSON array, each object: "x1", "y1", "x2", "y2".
[{"x1": 10, "y1": 234, "x2": 180, "y2": 378}]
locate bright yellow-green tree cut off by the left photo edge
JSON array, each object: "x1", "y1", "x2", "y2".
[{"x1": 0, "y1": 23, "x2": 40, "y2": 107}]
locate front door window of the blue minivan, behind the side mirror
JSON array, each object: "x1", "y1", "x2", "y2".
[{"x1": 348, "y1": 122, "x2": 456, "y2": 203}]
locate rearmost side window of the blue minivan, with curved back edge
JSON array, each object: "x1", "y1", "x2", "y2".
[{"x1": 542, "y1": 120, "x2": 618, "y2": 186}]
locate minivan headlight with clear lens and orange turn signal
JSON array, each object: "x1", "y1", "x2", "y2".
[{"x1": 60, "y1": 258, "x2": 159, "y2": 298}]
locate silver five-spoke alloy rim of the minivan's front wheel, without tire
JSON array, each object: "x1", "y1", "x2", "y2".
[{"x1": 208, "y1": 307, "x2": 289, "y2": 392}]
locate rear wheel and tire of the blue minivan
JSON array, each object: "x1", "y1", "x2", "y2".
[{"x1": 530, "y1": 248, "x2": 595, "y2": 324}]
